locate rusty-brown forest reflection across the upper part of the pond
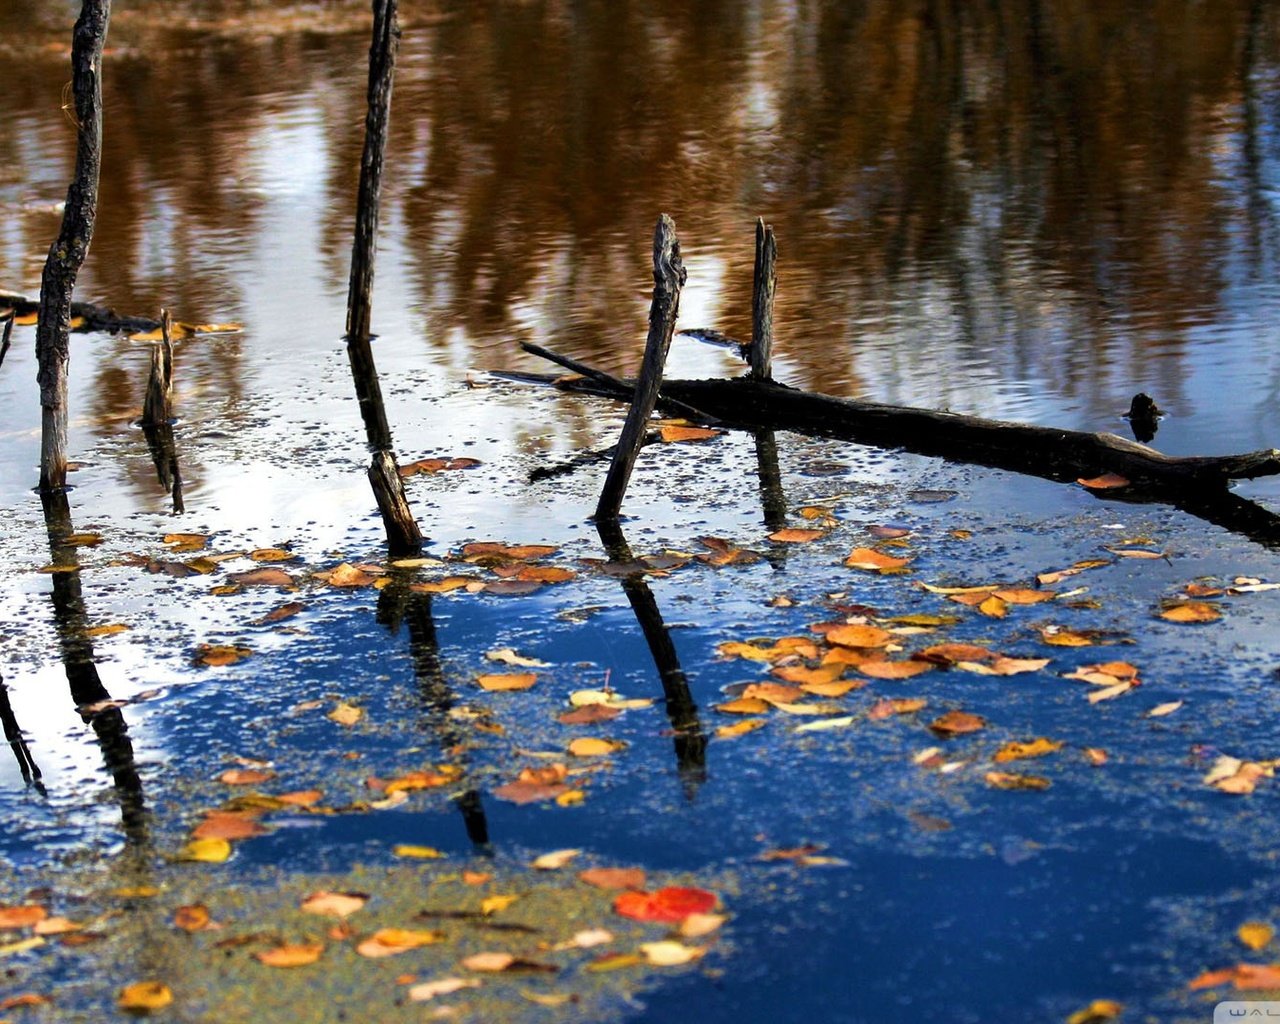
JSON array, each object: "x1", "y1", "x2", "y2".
[{"x1": 0, "y1": 0, "x2": 1280, "y2": 442}]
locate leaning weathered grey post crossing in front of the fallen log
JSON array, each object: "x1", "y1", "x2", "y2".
[{"x1": 595, "y1": 214, "x2": 686, "y2": 520}]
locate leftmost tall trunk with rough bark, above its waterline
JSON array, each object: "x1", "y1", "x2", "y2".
[{"x1": 36, "y1": 0, "x2": 111, "y2": 493}]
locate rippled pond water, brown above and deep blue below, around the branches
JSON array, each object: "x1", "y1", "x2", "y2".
[{"x1": 0, "y1": 0, "x2": 1280, "y2": 1024}]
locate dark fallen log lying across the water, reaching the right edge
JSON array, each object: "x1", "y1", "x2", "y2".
[{"x1": 498, "y1": 348, "x2": 1280, "y2": 547}]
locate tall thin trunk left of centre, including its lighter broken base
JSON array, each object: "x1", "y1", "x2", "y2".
[{"x1": 347, "y1": 0, "x2": 422, "y2": 554}]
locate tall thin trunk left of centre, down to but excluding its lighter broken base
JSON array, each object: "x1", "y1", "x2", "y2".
[{"x1": 347, "y1": 0, "x2": 399, "y2": 449}]
